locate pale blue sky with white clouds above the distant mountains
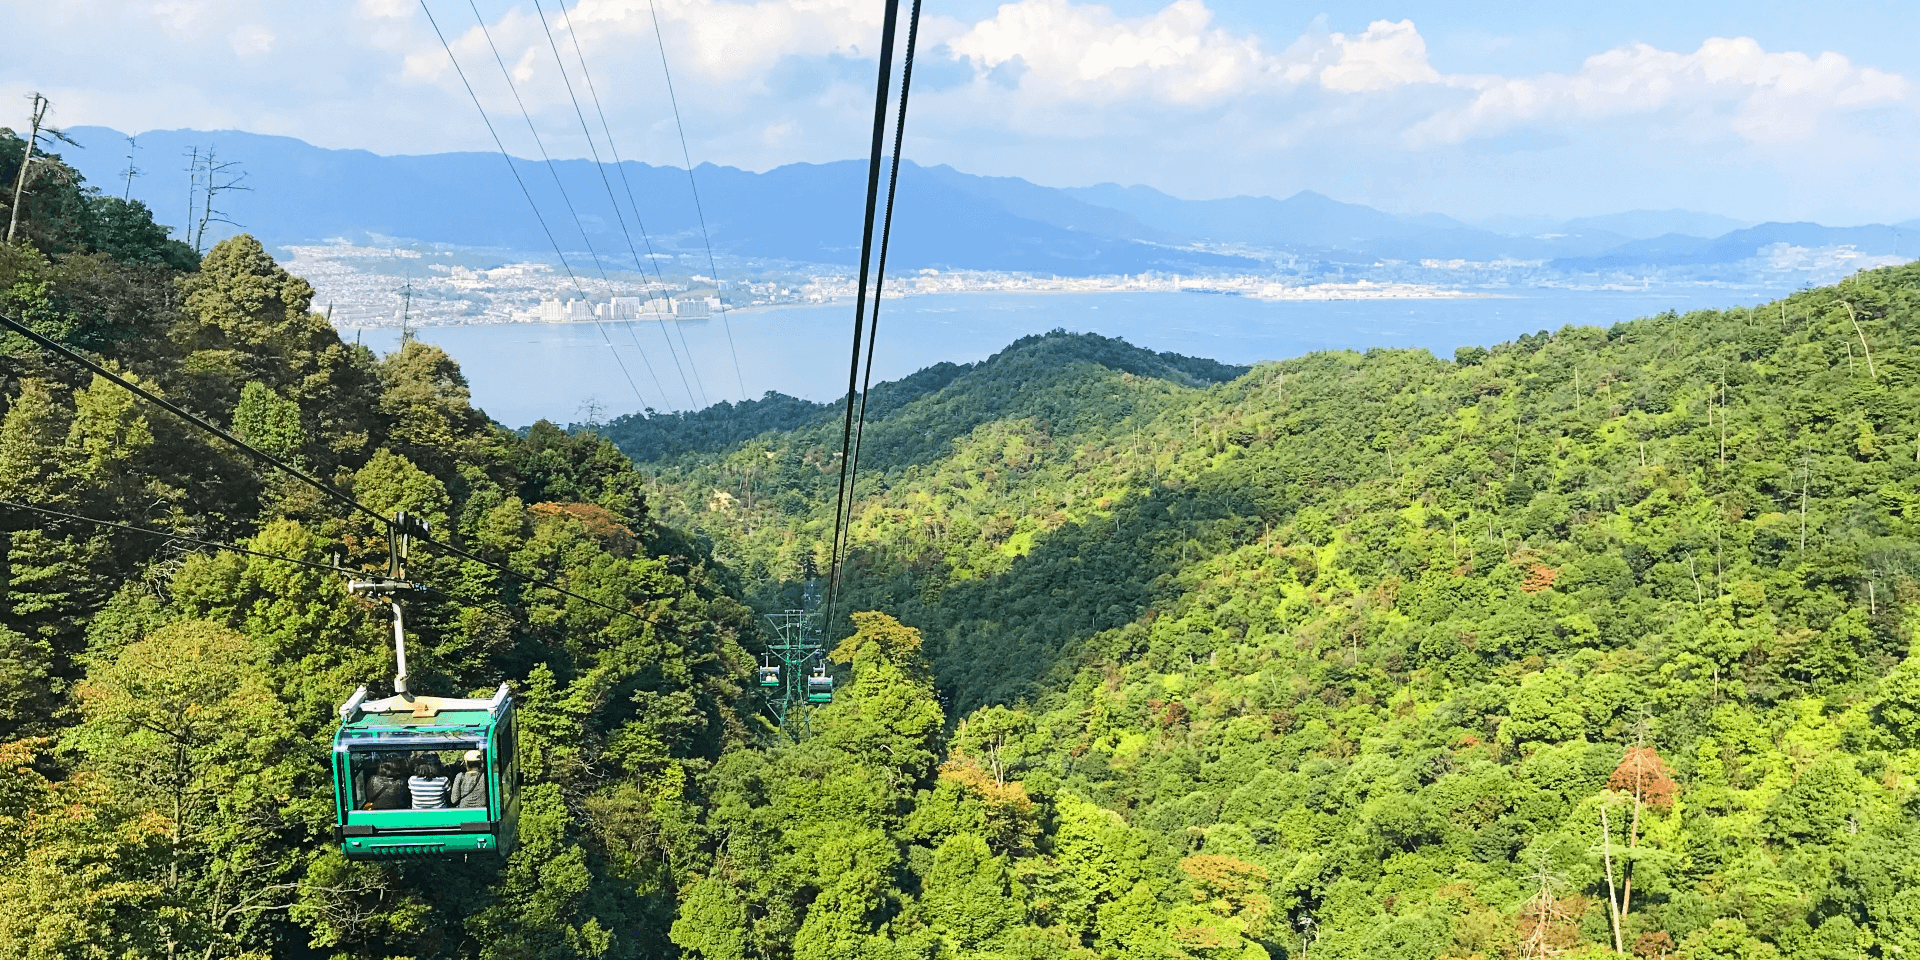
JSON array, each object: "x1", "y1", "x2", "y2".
[{"x1": 0, "y1": 0, "x2": 1920, "y2": 225}]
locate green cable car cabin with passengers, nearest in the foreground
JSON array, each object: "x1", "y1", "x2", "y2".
[{"x1": 334, "y1": 684, "x2": 520, "y2": 860}]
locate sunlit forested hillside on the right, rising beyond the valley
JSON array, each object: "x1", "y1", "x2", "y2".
[{"x1": 629, "y1": 267, "x2": 1920, "y2": 960}]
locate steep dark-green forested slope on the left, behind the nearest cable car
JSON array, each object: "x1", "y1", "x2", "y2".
[{"x1": 0, "y1": 138, "x2": 764, "y2": 960}]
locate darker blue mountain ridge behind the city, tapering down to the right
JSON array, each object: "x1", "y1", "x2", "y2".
[{"x1": 65, "y1": 127, "x2": 1260, "y2": 275}]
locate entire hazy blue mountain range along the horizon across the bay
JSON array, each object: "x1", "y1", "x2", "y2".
[{"x1": 65, "y1": 127, "x2": 1920, "y2": 276}]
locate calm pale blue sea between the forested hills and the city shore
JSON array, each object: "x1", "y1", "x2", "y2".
[{"x1": 344, "y1": 290, "x2": 1784, "y2": 426}]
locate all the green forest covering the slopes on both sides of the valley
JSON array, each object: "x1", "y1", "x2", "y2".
[{"x1": 0, "y1": 131, "x2": 1920, "y2": 960}]
